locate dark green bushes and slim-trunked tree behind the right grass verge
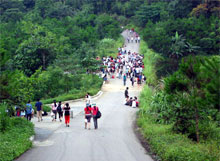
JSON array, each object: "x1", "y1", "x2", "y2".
[{"x1": 149, "y1": 57, "x2": 220, "y2": 141}]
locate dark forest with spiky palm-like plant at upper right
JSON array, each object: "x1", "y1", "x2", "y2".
[{"x1": 138, "y1": 0, "x2": 220, "y2": 78}]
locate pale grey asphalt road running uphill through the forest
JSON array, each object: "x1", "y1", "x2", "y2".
[{"x1": 16, "y1": 32, "x2": 152, "y2": 161}]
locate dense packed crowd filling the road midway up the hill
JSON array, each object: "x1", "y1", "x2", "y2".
[{"x1": 101, "y1": 36, "x2": 146, "y2": 86}]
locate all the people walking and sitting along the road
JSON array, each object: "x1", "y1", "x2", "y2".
[{"x1": 16, "y1": 29, "x2": 143, "y2": 130}]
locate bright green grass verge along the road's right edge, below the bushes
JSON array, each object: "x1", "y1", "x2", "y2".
[{"x1": 137, "y1": 88, "x2": 220, "y2": 161}]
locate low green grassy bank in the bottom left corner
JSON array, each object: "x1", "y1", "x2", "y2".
[{"x1": 0, "y1": 104, "x2": 34, "y2": 161}]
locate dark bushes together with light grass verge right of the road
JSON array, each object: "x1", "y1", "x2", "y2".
[{"x1": 138, "y1": 43, "x2": 220, "y2": 161}]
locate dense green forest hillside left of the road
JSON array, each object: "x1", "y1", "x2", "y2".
[{"x1": 0, "y1": 0, "x2": 124, "y2": 108}]
